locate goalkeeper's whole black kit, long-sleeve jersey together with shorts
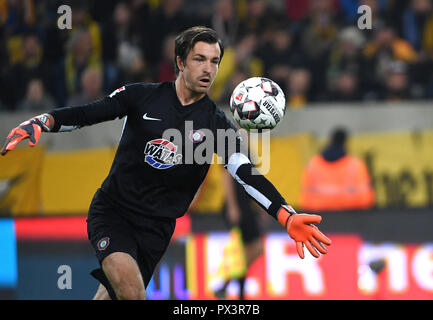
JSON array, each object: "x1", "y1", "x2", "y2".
[{"x1": 49, "y1": 82, "x2": 286, "y2": 298}]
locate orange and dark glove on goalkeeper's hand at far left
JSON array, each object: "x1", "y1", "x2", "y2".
[{"x1": 1, "y1": 114, "x2": 53, "y2": 156}]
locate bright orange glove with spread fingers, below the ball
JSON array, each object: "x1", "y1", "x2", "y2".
[{"x1": 277, "y1": 205, "x2": 331, "y2": 259}]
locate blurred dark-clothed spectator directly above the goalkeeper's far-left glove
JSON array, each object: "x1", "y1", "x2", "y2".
[{"x1": 16, "y1": 79, "x2": 54, "y2": 111}]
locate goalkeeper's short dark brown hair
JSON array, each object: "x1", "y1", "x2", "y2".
[{"x1": 174, "y1": 26, "x2": 224, "y2": 76}]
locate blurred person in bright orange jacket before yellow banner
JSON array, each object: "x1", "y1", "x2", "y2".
[{"x1": 299, "y1": 128, "x2": 375, "y2": 212}]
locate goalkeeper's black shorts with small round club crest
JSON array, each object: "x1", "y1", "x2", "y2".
[{"x1": 87, "y1": 189, "x2": 176, "y2": 299}]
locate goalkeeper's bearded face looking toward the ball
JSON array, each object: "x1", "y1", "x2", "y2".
[{"x1": 178, "y1": 41, "x2": 221, "y2": 93}]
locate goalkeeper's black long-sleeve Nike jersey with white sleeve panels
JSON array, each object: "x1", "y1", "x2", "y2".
[{"x1": 49, "y1": 82, "x2": 286, "y2": 219}]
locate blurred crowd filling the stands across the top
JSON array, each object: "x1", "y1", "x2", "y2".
[{"x1": 0, "y1": 0, "x2": 433, "y2": 111}]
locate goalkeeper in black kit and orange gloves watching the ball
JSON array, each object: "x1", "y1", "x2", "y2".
[{"x1": 1, "y1": 27, "x2": 331, "y2": 299}]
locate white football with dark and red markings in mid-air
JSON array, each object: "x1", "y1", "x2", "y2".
[{"x1": 230, "y1": 77, "x2": 286, "y2": 130}]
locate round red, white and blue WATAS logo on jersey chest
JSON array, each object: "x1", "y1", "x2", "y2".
[{"x1": 144, "y1": 138, "x2": 182, "y2": 169}]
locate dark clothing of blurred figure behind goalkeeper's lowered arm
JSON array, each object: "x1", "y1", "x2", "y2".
[{"x1": 224, "y1": 182, "x2": 262, "y2": 244}]
